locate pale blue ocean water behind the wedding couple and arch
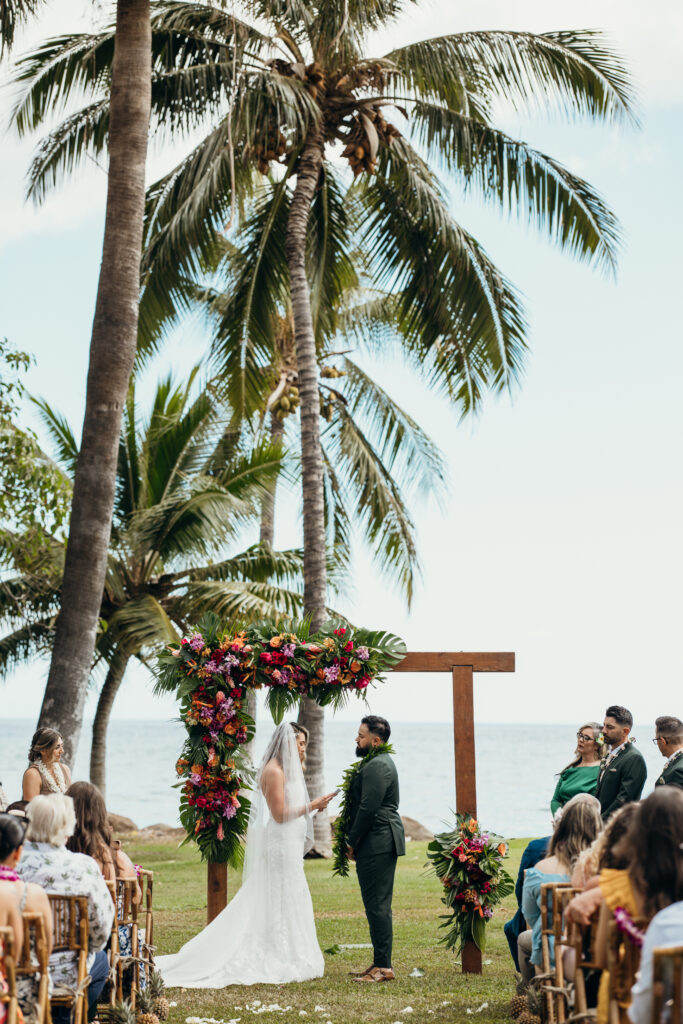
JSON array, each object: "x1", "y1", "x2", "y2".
[{"x1": 0, "y1": 719, "x2": 664, "y2": 839}]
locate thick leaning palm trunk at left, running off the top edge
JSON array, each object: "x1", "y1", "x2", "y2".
[{"x1": 39, "y1": 0, "x2": 152, "y2": 764}]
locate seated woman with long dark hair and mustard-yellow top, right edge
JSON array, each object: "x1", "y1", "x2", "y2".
[{"x1": 567, "y1": 785, "x2": 683, "y2": 1024}]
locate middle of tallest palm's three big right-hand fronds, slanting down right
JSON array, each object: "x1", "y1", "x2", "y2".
[{"x1": 411, "y1": 102, "x2": 620, "y2": 271}]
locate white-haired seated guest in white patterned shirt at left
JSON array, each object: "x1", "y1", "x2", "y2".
[{"x1": 17, "y1": 794, "x2": 114, "y2": 1024}]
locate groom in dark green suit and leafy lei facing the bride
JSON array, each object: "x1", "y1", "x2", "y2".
[{"x1": 347, "y1": 715, "x2": 405, "y2": 982}]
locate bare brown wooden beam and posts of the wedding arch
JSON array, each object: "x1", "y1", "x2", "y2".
[{"x1": 207, "y1": 650, "x2": 515, "y2": 974}]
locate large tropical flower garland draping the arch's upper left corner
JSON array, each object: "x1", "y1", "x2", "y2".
[{"x1": 156, "y1": 613, "x2": 405, "y2": 866}]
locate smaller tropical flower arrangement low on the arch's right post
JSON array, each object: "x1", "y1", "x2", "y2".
[{"x1": 427, "y1": 814, "x2": 514, "y2": 953}]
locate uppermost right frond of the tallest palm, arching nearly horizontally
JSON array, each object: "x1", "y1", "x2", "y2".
[{"x1": 384, "y1": 31, "x2": 635, "y2": 123}]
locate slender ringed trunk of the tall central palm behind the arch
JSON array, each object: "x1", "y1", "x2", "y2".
[{"x1": 285, "y1": 128, "x2": 332, "y2": 856}]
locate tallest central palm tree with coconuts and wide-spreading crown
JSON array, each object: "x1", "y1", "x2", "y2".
[{"x1": 16, "y1": 0, "x2": 632, "y2": 827}]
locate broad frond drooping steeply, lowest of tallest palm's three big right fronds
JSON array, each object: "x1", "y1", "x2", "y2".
[{"x1": 359, "y1": 139, "x2": 525, "y2": 403}]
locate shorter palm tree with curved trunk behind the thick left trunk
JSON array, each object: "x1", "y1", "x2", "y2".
[{"x1": 0, "y1": 369, "x2": 309, "y2": 793}]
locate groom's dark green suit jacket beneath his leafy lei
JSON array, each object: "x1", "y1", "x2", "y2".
[{"x1": 348, "y1": 754, "x2": 405, "y2": 859}]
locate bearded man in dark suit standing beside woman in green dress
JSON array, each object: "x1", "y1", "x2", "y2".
[{"x1": 595, "y1": 705, "x2": 647, "y2": 821}]
